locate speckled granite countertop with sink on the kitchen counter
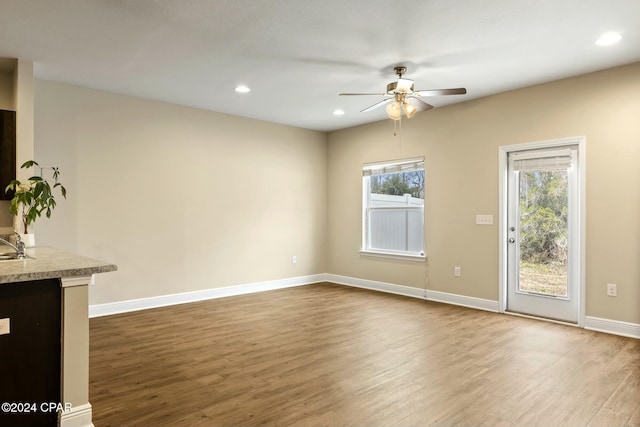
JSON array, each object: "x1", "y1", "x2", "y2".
[{"x1": 0, "y1": 245, "x2": 118, "y2": 283}]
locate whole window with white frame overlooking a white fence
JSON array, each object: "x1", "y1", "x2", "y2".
[{"x1": 362, "y1": 159, "x2": 424, "y2": 260}]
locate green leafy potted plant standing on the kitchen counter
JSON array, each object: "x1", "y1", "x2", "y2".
[{"x1": 5, "y1": 160, "x2": 67, "y2": 244}]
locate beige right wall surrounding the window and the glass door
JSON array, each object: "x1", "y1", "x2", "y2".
[{"x1": 327, "y1": 64, "x2": 640, "y2": 323}]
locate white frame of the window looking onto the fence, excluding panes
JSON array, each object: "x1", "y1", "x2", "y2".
[{"x1": 360, "y1": 157, "x2": 426, "y2": 262}]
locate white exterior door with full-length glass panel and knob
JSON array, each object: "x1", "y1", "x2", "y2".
[{"x1": 507, "y1": 147, "x2": 579, "y2": 322}]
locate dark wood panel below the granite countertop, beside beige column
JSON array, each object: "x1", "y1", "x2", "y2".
[{"x1": 0, "y1": 279, "x2": 62, "y2": 427}]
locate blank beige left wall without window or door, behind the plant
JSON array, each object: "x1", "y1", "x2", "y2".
[{"x1": 35, "y1": 80, "x2": 327, "y2": 304}]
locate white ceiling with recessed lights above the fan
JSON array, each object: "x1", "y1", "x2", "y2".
[{"x1": 0, "y1": 0, "x2": 640, "y2": 131}]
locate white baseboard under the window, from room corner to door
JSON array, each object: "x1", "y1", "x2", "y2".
[{"x1": 325, "y1": 274, "x2": 499, "y2": 313}]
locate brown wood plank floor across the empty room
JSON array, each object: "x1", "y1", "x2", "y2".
[{"x1": 90, "y1": 283, "x2": 640, "y2": 427}]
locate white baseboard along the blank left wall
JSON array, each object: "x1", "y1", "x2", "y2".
[{"x1": 89, "y1": 274, "x2": 325, "y2": 318}]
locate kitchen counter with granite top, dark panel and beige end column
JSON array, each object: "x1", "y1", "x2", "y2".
[{"x1": 0, "y1": 245, "x2": 117, "y2": 427}]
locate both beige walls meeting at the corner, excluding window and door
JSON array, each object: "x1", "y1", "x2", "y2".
[{"x1": 35, "y1": 64, "x2": 640, "y2": 323}]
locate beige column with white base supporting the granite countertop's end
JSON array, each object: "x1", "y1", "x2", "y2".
[{"x1": 59, "y1": 275, "x2": 93, "y2": 427}]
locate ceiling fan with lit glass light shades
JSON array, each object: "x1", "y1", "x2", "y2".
[{"x1": 339, "y1": 67, "x2": 467, "y2": 120}]
